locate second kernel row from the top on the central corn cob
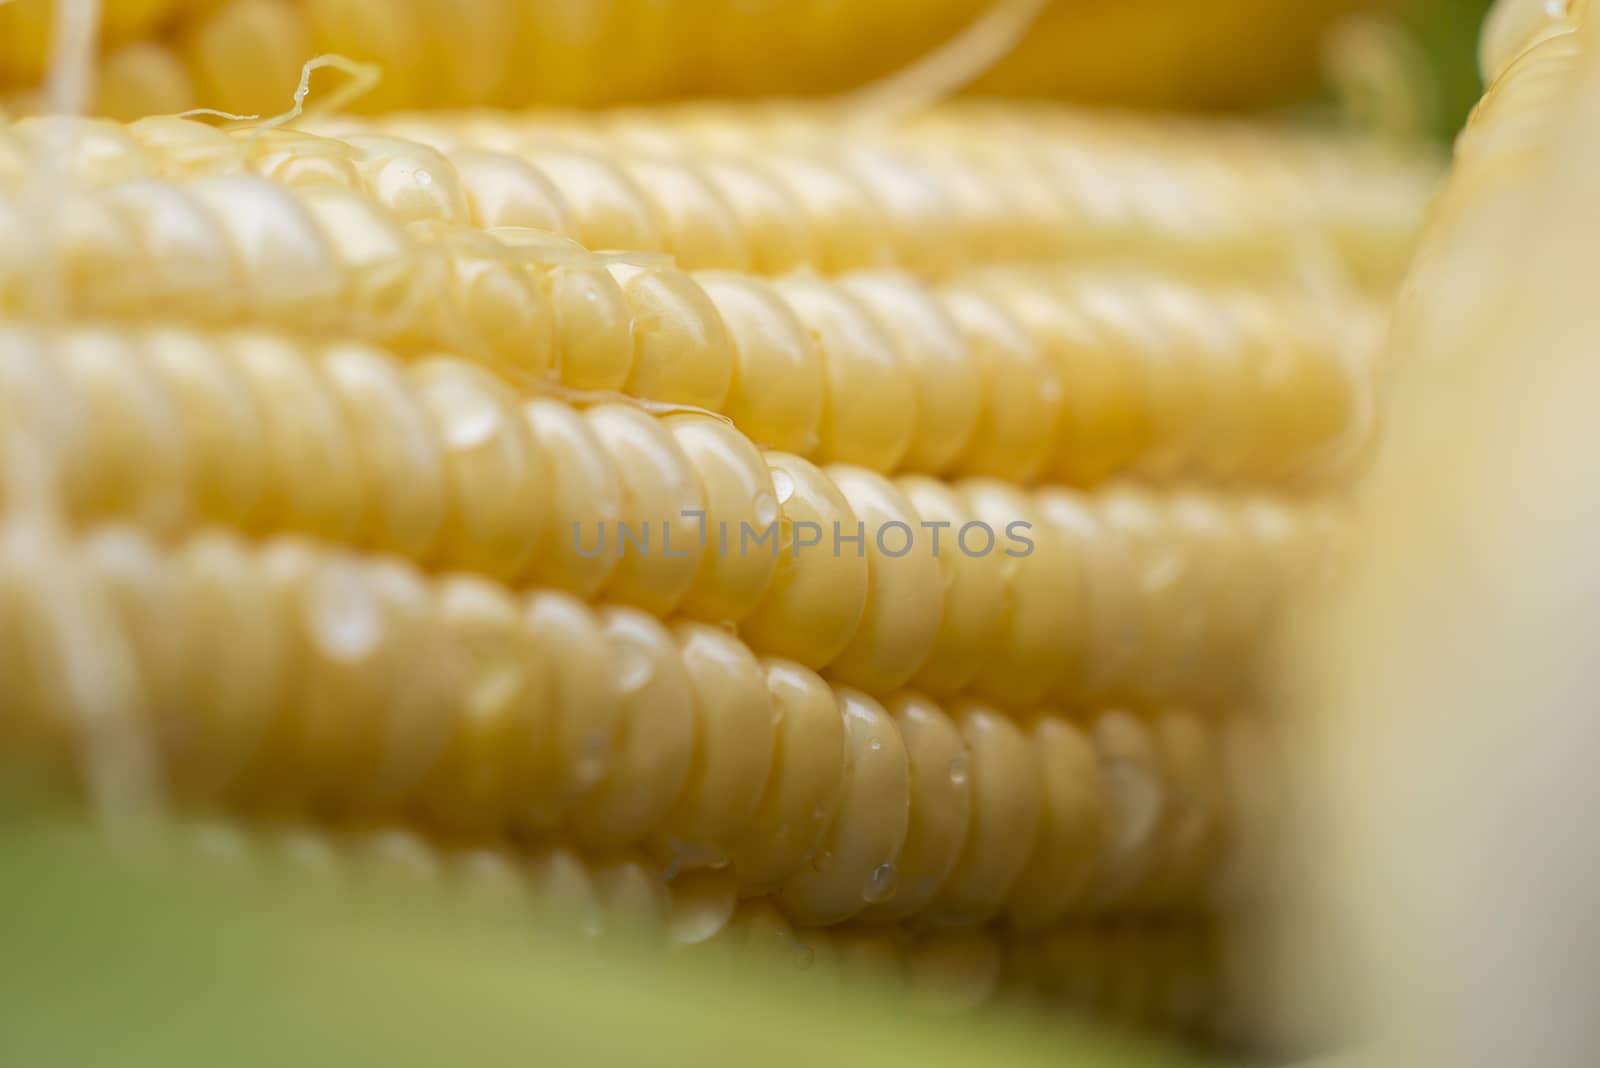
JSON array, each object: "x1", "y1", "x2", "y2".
[{"x1": 0, "y1": 167, "x2": 1376, "y2": 484}]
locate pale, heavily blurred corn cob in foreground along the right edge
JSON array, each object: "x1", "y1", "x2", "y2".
[{"x1": 1293, "y1": 0, "x2": 1600, "y2": 1068}]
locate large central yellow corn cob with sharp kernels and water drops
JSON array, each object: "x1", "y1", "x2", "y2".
[{"x1": 0, "y1": 3, "x2": 1452, "y2": 1061}]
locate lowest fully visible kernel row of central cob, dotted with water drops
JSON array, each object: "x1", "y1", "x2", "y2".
[{"x1": 0, "y1": 521, "x2": 1270, "y2": 926}]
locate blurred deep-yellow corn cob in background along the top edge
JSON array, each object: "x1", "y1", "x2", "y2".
[{"x1": 0, "y1": 0, "x2": 1394, "y2": 118}]
